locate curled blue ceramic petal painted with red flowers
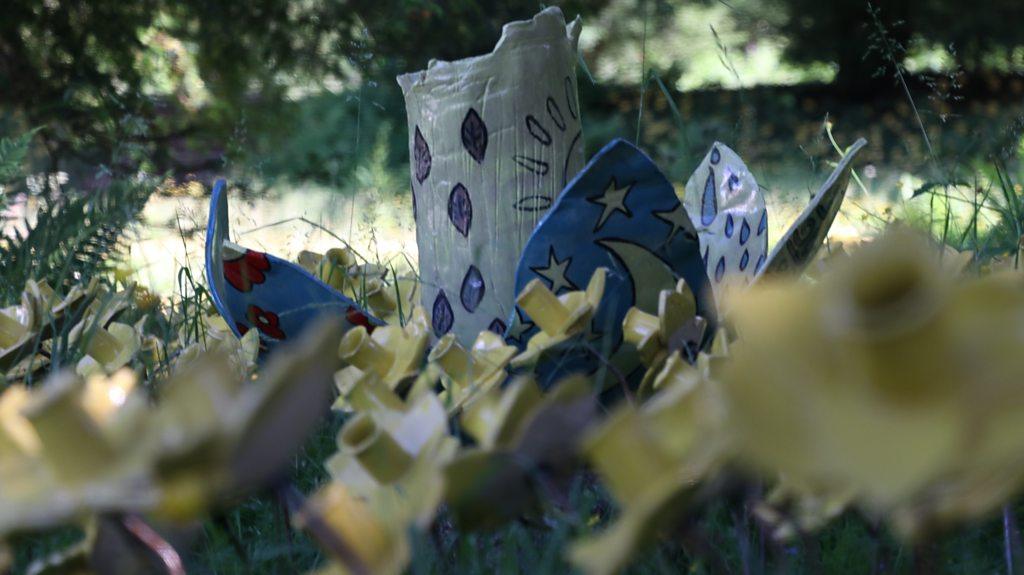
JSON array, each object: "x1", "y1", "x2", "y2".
[{"x1": 206, "y1": 180, "x2": 383, "y2": 349}]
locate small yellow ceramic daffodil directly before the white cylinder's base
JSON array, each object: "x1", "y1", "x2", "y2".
[{"x1": 427, "y1": 330, "x2": 517, "y2": 413}]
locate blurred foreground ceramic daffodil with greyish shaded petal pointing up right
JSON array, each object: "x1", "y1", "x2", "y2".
[{"x1": 148, "y1": 320, "x2": 341, "y2": 519}]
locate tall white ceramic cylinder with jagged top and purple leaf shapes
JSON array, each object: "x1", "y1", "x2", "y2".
[{"x1": 398, "y1": 7, "x2": 584, "y2": 346}]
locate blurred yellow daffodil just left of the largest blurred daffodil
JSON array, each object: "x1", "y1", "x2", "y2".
[{"x1": 570, "y1": 346, "x2": 730, "y2": 575}]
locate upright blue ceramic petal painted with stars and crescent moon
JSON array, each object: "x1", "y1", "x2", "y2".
[{"x1": 507, "y1": 139, "x2": 716, "y2": 380}]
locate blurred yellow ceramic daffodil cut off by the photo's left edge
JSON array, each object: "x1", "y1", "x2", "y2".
[{"x1": 0, "y1": 372, "x2": 157, "y2": 534}]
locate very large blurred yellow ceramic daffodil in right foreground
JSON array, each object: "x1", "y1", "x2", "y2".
[{"x1": 722, "y1": 231, "x2": 1024, "y2": 533}]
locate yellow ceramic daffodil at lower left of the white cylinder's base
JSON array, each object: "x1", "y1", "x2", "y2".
[{"x1": 335, "y1": 307, "x2": 430, "y2": 410}]
